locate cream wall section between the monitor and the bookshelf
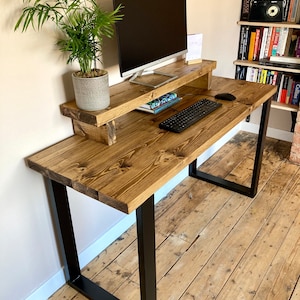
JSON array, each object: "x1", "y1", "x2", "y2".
[{"x1": 187, "y1": 0, "x2": 241, "y2": 78}]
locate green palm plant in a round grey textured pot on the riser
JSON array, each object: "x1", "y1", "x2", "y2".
[{"x1": 15, "y1": 0, "x2": 123, "y2": 111}]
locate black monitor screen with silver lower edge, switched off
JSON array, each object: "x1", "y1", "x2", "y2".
[{"x1": 114, "y1": 0, "x2": 187, "y2": 77}]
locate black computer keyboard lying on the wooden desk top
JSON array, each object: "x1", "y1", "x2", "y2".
[{"x1": 159, "y1": 99, "x2": 222, "y2": 133}]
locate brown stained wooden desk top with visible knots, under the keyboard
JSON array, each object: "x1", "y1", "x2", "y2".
[{"x1": 26, "y1": 77, "x2": 276, "y2": 213}]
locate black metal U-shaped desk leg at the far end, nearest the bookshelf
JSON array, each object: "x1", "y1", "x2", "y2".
[{"x1": 189, "y1": 100, "x2": 271, "y2": 197}]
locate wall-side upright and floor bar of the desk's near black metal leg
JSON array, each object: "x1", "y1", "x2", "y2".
[{"x1": 45, "y1": 178, "x2": 117, "y2": 300}]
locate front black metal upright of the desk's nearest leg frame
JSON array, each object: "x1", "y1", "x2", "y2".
[{"x1": 136, "y1": 195, "x2": 156, "y2": 300}]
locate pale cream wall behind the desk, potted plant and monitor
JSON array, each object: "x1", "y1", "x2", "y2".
[{"x1": 0, "y1": 0, "x2": 290, "y2": 300}]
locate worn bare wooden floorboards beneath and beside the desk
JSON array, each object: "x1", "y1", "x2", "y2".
[{"x1": 51, "y1": 132, "x2": 300, "y2": 300}]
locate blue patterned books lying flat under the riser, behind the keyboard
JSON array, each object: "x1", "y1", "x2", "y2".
[{"x1": 137, "y1": 93, "x2": 181, "y2": 114}]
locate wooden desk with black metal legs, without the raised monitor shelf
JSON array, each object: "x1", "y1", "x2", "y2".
[{"x1": 26, "y1": 62, "x2": 276, "y2": 300}]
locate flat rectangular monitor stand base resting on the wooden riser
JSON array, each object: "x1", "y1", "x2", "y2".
[{"x1": 129, "y1": 70, "x2": 177, "y2": 88}]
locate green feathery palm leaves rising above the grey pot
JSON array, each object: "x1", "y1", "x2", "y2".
[{"x1": 15, "y1": 0, "x2": 123, "y2": 73}]
